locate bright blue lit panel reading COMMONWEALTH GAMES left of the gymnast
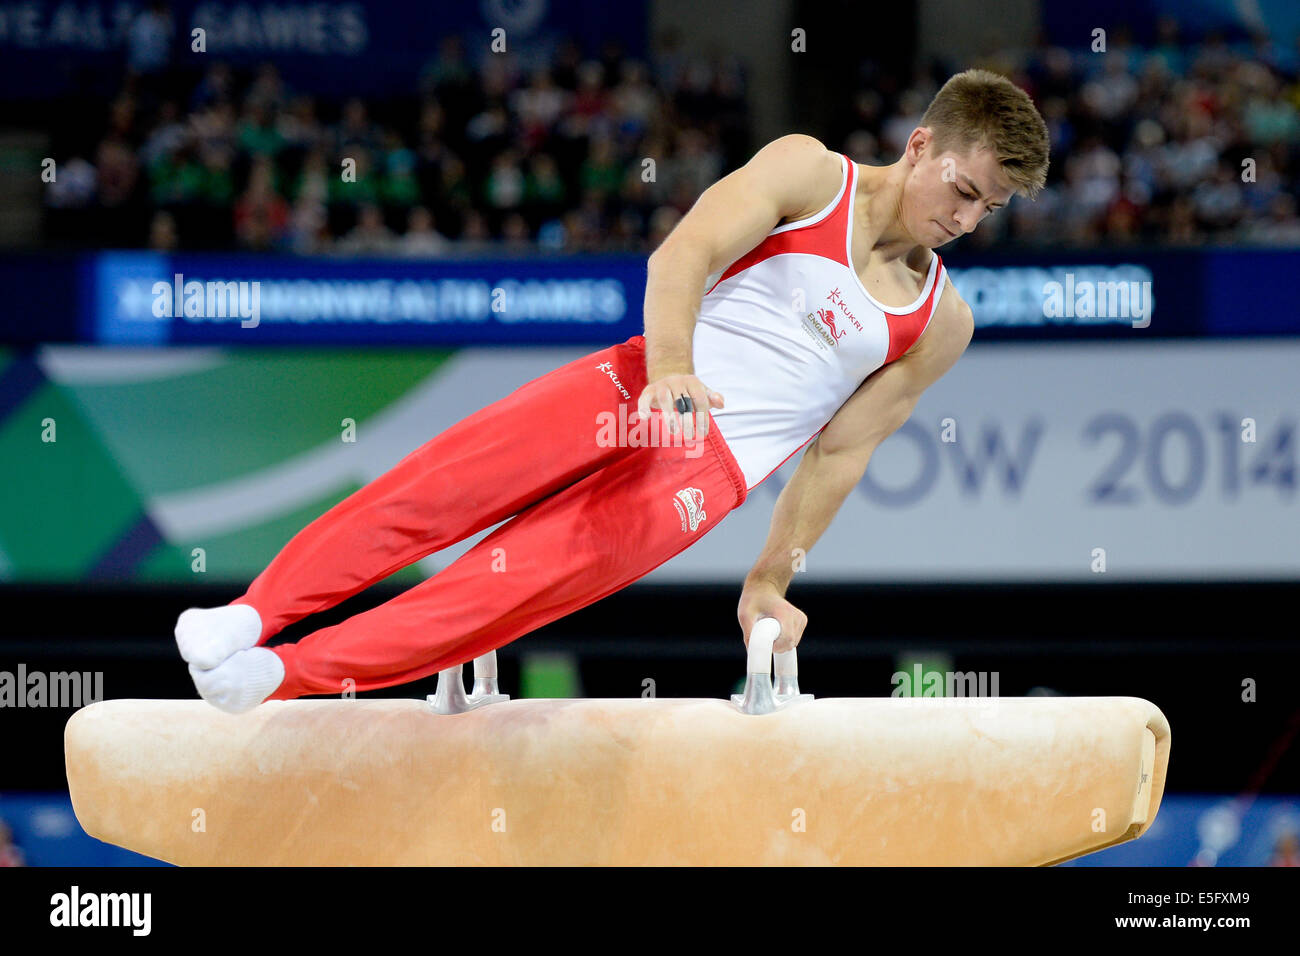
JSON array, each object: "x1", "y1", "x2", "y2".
[{"x1": 90, "y1": 252, "x2": 646, "y2": 346}]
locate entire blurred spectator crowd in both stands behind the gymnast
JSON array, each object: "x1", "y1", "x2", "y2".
[{"x1": 35, "y1": 8, "x2": 1300, "y2": 256}]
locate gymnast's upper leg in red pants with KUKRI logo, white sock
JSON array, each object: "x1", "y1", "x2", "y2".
[{"x1": 176, "y1": 336, "x2": 646, "y2": 674}]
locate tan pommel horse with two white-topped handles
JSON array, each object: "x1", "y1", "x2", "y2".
[{"x1": 64, "y1": 618, "x2": 1170, "y2": 866}]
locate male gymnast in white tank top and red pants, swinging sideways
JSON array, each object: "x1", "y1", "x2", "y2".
[{"x1": 176, "y1": 70, "x2": 1048, "y2": 713}]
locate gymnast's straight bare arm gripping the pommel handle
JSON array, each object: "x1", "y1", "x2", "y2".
[{"x1": 738, "y1": 287, "x2": 975, "y2": 650}]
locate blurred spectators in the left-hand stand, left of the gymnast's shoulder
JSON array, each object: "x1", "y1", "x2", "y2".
[{"x1": 46, "y1": 14, "x2": 749, "y2": 256}]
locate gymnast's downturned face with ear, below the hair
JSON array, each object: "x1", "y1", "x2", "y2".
[{"x1": 901, "y1": 126, "x2": 1015, "y2": 248}]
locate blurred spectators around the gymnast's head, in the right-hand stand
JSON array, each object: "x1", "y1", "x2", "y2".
[{"x1": 832, "y1": 17, "x2": 1300, "y2": 248}]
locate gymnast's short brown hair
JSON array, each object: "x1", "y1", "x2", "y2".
[{"x1": 919, "y1": 69, "x2": 1050, "y2": 199}]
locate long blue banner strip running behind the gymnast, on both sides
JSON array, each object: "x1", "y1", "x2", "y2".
[{"x1": 0, "y1": 248, "x2": 1300, "y2": 347}]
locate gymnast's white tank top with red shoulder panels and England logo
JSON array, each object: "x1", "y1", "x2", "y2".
[{"x1": 692, "y1": 153, "x2": 946, "y2": 490}]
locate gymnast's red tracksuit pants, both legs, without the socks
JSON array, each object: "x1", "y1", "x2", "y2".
[{"x1": 231, "y1": 336, "x2": 746, "y2": 700}]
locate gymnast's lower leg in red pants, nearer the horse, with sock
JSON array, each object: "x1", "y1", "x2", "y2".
[{"x1": 195, "y1": 412, "x2": 745, "y2": 710}]
